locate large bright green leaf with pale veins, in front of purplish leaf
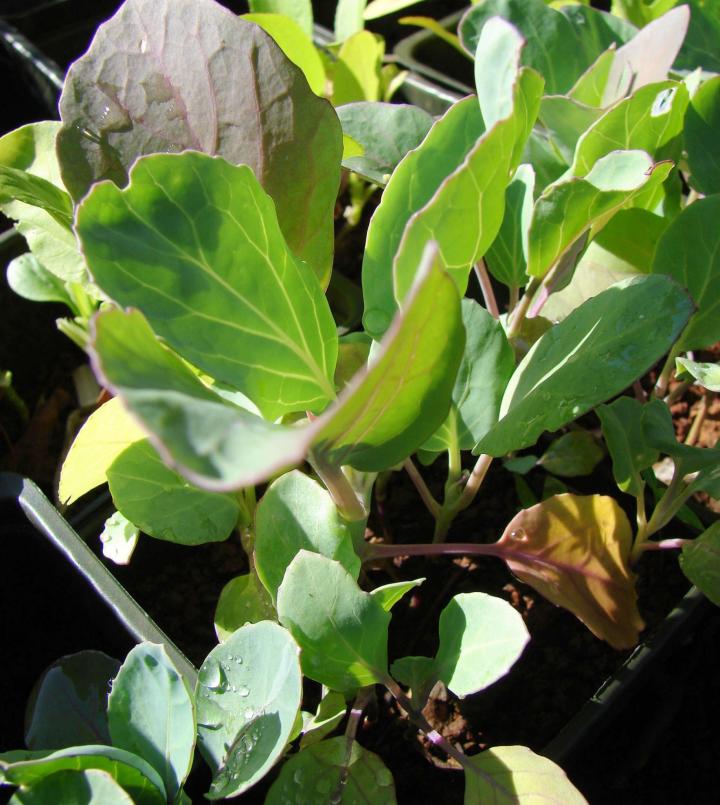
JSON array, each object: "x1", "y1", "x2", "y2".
[{"x1": 77, "y1": 152, "x2": 337, "y2": 419}]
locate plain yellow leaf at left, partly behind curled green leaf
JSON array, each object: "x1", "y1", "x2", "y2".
[{"x1": 58, "y1": 397, "x2": 147, "y2": 503}]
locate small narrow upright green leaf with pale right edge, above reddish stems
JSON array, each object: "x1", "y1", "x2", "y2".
[{"x1": 485, "y1": 165, "x2": 535, "y2": 288}]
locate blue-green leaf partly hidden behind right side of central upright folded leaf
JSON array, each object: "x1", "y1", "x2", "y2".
[{"x1": 423, "y1": 299, "x2": 515, "y2": 452}]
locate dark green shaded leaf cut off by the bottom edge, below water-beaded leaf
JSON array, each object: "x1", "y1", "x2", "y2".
[{"x1": 265, "y1": 735, "x2": 396, "y2": 805}]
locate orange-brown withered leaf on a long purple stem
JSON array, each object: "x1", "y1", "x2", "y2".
[{"x1": 497, "y1": 494, "x2": 645, "y2": 649}]
